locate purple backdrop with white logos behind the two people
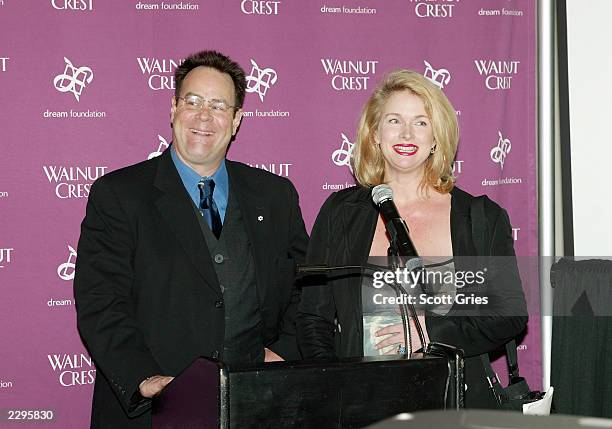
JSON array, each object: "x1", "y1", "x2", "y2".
[{"x1": 0, "y1": 0, "x2": 541, "y2": 428}]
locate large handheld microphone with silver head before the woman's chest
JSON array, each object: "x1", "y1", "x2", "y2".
[{"x1": 372, "y1": 184, "x2": 419, "y2": 257}]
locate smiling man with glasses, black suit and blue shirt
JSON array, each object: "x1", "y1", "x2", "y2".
[{"x1": 74, "y1": 51, "x2": 308, "y2": 428}]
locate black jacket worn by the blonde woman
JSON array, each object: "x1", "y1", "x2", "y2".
[{"x1": 297, "y1": 187, "x2": 527, "y2": 408}]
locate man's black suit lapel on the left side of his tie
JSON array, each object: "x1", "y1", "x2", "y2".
[{"x1": 154, "y1": 149, "x2": 222, "y2": 297}]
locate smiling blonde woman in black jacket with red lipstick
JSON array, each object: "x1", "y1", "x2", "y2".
[{"x1": 297, "y1": 70, "x2": 527, "y2": 408}]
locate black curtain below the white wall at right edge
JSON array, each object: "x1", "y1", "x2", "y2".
[{"x1": 551, "y1": 258, "x2": 612, "y2": 417}]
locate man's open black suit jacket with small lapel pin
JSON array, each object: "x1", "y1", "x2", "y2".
[{"x1": 74, "y1": 150, "x2": 308, "y2": 428}]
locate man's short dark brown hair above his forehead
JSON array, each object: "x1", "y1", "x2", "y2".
[{"x1": 174, "y1": 51, "x2": 246, "y2": 107}]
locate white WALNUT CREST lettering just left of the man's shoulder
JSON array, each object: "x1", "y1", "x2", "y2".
[{"x1": 43, "y1": 165, "x2": 108, "y2": 200}]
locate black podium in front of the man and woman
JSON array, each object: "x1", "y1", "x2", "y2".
[{"x1": 153, "y1": 346, "x2": 463, "y2": 429}]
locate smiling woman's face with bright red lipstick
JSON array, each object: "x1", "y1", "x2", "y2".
[{"x1": 375, "y1": 90, "x2": 435, "y2": 180}]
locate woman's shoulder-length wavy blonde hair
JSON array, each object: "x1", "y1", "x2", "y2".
[{"x1": 352, "y1": 70, "x2": 459, "y2": 193}]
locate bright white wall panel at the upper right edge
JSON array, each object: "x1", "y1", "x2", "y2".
[{"x1": 566, "y1": 0, "x2": 612, "y2": 257}]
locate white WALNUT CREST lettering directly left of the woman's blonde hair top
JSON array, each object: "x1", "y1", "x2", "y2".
[{"x1": 321, "y1": 58, "x2": 378, "y2": 91}]
